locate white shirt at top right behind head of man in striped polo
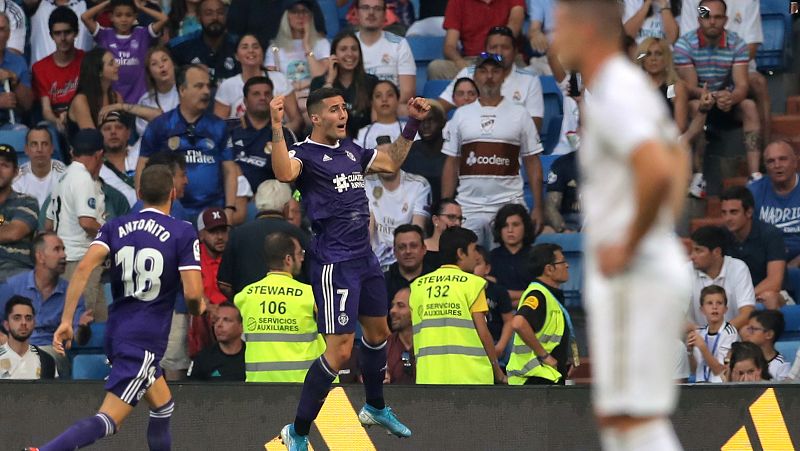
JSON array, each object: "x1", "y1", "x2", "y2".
[{"x1": 675, "y1": 0, "x2": 764, "y2": 44}]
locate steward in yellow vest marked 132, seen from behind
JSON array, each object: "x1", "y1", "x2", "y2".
[{"x1": 409, "y1": 227, "x2": 505, "y2": 385}]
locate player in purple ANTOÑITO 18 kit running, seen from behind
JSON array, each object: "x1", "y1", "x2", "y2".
[{"x1": 26, "y1": 165, "x2": 205, "y2": 451}]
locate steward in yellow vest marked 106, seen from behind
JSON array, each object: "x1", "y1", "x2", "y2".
[{"x1": 234, "y1": 233, "x2": 325, "y2": 382}]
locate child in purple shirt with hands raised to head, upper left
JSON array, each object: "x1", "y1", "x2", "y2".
[{"x1": 81, "y1": 0, "x2": 169, "y2": 104}]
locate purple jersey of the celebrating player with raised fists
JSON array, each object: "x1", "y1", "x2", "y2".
[{"x1": 289, "y1": 138, "x2": 377, "y2": 264}]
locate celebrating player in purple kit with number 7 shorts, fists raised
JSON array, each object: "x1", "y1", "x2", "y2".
[{"x1": 270, "y1": 88, "x2": 430, "y2": 451}]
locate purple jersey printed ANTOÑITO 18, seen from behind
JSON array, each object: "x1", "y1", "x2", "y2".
[{"x1": 92, "y1": 208, "x2": 200, "y2": 358}]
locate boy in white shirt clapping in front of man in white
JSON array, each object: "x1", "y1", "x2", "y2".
[{"x1": 687, "y1": 285, "x2": 739, "y2": 382}]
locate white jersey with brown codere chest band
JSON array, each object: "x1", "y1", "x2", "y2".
[{"x1": 442, "y1": 98, "x2": 542, "y2": 212}]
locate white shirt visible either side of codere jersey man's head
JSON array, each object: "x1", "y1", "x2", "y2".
[{"x1": 439, "y1": 66, "x2": 544, "y2": 117}]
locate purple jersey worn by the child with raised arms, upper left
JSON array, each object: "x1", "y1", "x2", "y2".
[{"x1": 94, "y1": 26, "x2": 156, "y2": 104}]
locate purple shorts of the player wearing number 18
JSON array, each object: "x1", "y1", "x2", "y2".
[{"x1": 106, "y1": 342, "x2": 162, "y2": 406}]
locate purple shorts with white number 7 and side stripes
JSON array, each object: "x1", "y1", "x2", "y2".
[{"x1": 309, "y1": 254, "x2": 389, "y2": 334}]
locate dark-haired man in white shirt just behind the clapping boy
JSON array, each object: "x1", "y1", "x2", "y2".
[{"x1": 687, "y1": 226, "x2": 756, "y2": 329}]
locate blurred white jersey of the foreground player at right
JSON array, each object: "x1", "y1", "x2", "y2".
[{"x1": 579, "y1": 53, "x2": 680, "y2": 256}]
